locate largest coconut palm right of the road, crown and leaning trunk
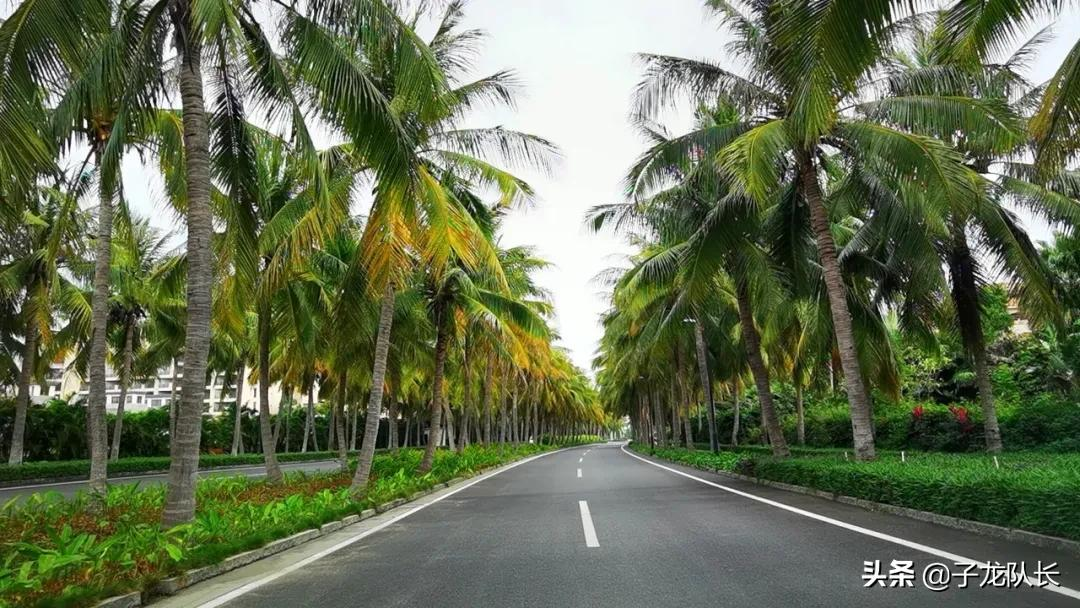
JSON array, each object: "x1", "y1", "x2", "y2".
[{"x1": 637, "y1": 0, "x2": 987, "y2": 460}]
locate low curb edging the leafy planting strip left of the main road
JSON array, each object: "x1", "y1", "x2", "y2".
[{"x1": 94, "y1": 446, "x2": 580, "y2": 608}]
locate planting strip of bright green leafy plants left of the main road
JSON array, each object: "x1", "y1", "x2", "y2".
[{"x1": 0, "y1": 445, "x2": 600, "y2": 606}]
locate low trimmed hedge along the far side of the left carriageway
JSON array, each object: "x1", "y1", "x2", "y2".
[{"x1": 0, "y1": 450, "x2": 360, "y2": 483}]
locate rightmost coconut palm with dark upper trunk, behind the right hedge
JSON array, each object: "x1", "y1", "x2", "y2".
[{"x1": 849, "y1": 12, "x2": 1080, "y2": 451}]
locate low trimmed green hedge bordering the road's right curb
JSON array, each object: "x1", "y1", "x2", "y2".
[{"x1": 634, "y1": 445, "x2": 1080, "y2": 540}]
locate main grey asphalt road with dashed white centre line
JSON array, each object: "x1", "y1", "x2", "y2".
[{"x1": 198, "y1": 444, "x2": 1080, "y2": 608}]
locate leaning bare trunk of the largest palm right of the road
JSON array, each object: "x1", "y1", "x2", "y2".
[{"x1": 798, "y1": 150, "x2": 877, "y2": 460}]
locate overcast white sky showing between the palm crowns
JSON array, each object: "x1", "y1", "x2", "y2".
[{"x1": 113, "y1": 0, "x2": 1080, "y2": 370}]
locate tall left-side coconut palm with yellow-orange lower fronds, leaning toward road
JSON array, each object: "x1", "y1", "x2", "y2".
[{"x1": 352, "y1": 2, "x2": 556, "y2": 491}]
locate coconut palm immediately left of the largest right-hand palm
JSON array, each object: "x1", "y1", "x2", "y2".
[{"x1": 593, "y1": 104, "x2": 788, "y2": 456}]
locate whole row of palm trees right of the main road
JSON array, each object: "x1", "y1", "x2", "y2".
[{"x1": 591, "y1": 0, "x2": 1080, "y2": 460}]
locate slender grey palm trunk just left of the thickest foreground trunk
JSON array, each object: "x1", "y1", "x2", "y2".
[{"x1": 86, "y1": 167, "x2": 112, "y2": 494}]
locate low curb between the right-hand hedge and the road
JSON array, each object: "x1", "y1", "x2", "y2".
[{"x1": 638, "y1": 452, "x2": 1080, "y2": 555}]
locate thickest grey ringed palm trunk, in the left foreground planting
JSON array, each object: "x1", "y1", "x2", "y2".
[{"x1": 162, "y1": 0, "x2": 214, "y2": 528}]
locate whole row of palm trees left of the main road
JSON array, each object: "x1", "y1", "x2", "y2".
[{"x1": 0, "y1": 0, "x2": 605, "y2": 526}]
